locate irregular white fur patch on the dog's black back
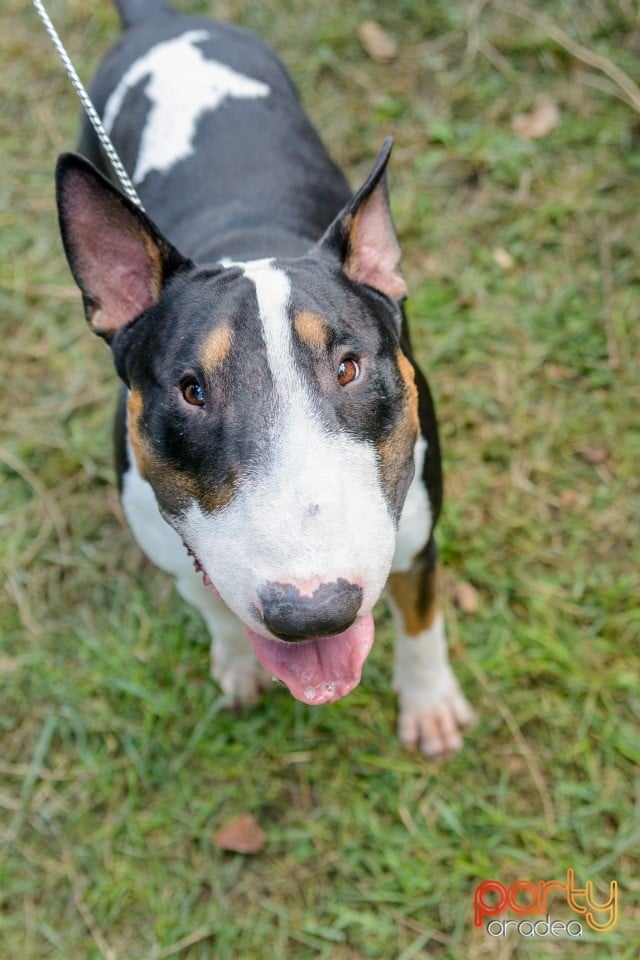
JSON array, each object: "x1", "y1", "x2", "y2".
[{"x1": 103, "y1": 30, "x2": 271, "y2": 183}]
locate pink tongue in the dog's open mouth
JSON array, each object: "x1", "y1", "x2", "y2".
[{"x1": 247, "y1": 614, "x2": 374, "y2": 705}]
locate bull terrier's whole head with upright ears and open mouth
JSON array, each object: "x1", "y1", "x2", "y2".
[{"x1": 57, "y1": 142, "x2": 418, "y2": 703}]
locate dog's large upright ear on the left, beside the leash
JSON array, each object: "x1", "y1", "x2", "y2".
[{"x1": 56, "y1": 153, "x2": 191, "y2": 341}]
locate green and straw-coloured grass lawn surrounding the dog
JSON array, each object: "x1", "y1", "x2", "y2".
[{"x1": 0, "y1": 0, "x2": 640, "y2": 960}]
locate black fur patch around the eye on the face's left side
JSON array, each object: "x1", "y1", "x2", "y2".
[{"x1": 113, "y1": 268, "x2": 273, "y2": 516}]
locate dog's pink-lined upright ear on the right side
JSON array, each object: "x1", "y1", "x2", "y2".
[{"x1": 317, "y1": 137, "x2": 407, "y2": 301}]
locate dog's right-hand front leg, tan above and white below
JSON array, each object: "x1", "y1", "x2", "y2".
[{"x1": 388, "y1": 545, "x2": 473, "y2": 759}]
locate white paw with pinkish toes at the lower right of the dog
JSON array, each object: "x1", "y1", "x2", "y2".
[{"x1": 398, "y1": 677, "x2": 473, "y2": 760}]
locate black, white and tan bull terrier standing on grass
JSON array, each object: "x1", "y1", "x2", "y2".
[{"x1": 56, "y1": 0, "x2": 472, "y2": 757}]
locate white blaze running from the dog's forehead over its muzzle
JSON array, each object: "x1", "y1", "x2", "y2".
[{"x1": 176, "y1": 260, "x2": 395, "y2": 633}]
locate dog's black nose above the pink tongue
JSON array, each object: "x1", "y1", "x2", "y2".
[{"x1": 258, "y1": 577, "x2": 362, "y2": 642}]
